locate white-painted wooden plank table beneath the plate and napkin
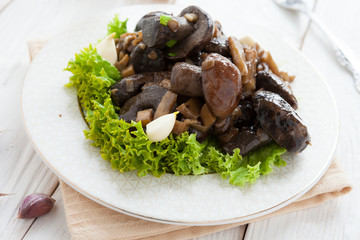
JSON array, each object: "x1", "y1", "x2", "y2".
[{"x1": 0, "y1": 0, "x2": 360, "y2": 240}]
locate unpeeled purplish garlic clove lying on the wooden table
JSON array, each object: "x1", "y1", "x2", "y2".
[{"x1": 18, "y1": 193, "x2": 56, "y2": 219}]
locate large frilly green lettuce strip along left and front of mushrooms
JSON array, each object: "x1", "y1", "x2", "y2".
[{"x1": 65, "y1": 42, "x2": 286, "y2": 186}]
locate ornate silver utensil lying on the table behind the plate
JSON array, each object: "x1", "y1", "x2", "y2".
[{"x1": 273, "y1": 0, "x2": 360, "y2": 92}]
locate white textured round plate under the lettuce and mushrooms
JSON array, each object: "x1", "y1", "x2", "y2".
[{"x1": 22, "y1": 5, "x2": 338, "y2": 225}]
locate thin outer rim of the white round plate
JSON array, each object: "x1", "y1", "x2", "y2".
[{"x1": 20, "y1": 4, "x2": 340, "y2": 226}]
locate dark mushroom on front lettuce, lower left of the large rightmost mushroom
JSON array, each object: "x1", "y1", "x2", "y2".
[{"x1": 222, "y1": 128, "x2": 271, "y2": 156}]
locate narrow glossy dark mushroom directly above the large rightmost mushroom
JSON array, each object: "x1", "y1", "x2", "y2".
[{"x1": 256, "y1": 71, "x2": 298, "y2": 109}]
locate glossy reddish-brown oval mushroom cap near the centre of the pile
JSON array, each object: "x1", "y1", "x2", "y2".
[{"x1": 202, "y1": 53, "x2": 241, "y2": 119}]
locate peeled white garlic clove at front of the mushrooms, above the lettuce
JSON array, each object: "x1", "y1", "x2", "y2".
[{"x1": 146, "y1": 112, "x2": 178, "y2": 142}]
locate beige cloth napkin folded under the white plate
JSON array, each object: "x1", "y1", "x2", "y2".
[{"x1": 28, "y1": 41, "x2": 352, "y2": 240}]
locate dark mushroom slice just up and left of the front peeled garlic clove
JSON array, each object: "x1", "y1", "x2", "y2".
[{"x1": 119, "y1": 85, "x2": 167, "y2": 122}]
